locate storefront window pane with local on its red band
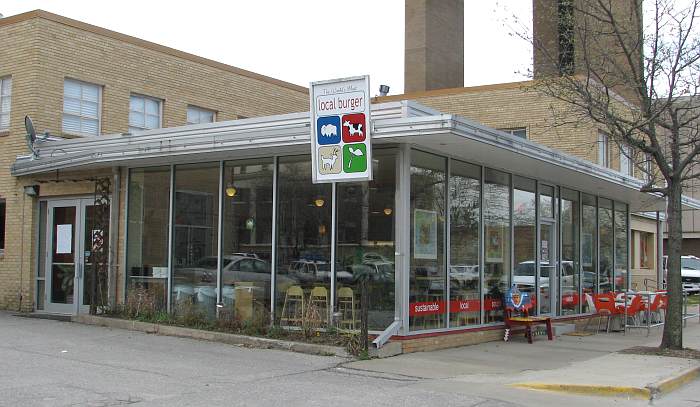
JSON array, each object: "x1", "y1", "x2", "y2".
[{"x1": 448, "y1": 160, "x2": 481, "y2": 326}]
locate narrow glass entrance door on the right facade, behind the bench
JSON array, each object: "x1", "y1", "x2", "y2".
[{"x1": 537, "y1": 220, "x2": 557, "y2": 314}]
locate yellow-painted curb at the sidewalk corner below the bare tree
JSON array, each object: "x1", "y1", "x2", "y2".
[{"x1": 510, "y1": 366, "x2": 700, "y2": 400}]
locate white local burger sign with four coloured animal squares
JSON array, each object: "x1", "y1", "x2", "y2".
[{"x1": 311, "y1": 75, "x2": 372, "y2": 183}]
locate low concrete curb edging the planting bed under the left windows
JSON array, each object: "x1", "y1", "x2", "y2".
[{"x1": 71, "y1": 315, "x2": 352, "y2": 359}]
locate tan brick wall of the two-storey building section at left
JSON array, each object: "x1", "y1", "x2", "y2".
[{"x1": 0, "y1": 11, "x2": 308, "y2": 311}]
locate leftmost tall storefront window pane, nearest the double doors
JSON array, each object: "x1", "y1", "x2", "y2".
[{"x1": 126, "y1": 167, "x2": 170, "y2": 310}]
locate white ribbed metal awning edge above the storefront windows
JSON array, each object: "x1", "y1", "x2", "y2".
[{"x1": 12, "y1": 101, "x2": 700, "y2": 212}]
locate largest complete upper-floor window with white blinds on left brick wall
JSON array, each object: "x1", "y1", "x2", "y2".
[{"x1": 62, "y1": 79, "x2": 102, "y2": 136}]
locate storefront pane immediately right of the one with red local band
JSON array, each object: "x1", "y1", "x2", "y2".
[{"x1": 483, "y1": 169, "x2": 511, "y2": 323}]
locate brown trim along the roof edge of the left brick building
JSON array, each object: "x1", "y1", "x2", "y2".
[{"x1": 0, "y1": 9, "x2": 309, "y2": 94}]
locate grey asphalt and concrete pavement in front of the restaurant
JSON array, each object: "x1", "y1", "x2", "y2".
[{"x1": 0, "y1": 312, "x2": 700, "y2": 407}]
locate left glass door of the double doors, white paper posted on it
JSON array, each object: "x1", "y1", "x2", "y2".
[{"x1": 45, "y1": 200, "x2": 82, "y2": 314}]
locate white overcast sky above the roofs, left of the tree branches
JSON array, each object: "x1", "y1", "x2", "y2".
[{"x1": 0, "y1": 0, "x2": 532, "y2": 94}]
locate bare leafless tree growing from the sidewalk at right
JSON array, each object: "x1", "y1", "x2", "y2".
[{"x1": 519, "y1": 0, "x2": 700, "y2": 349}]
